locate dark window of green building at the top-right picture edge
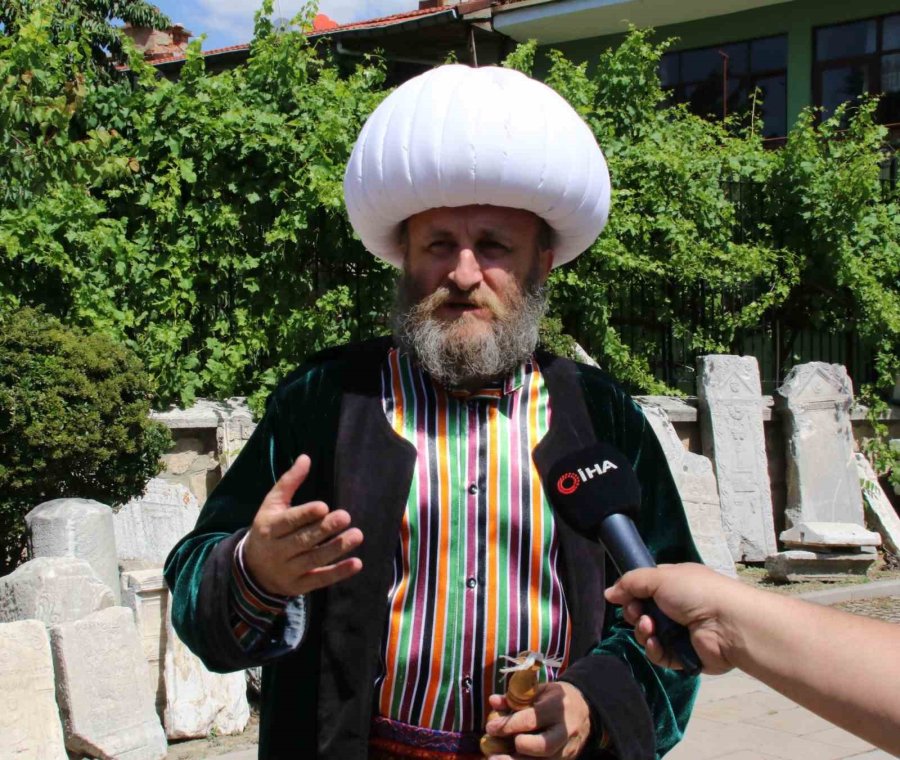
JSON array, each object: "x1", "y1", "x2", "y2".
[{"x1": 813, "y1": 14, "x2": 900, "y2": 124}]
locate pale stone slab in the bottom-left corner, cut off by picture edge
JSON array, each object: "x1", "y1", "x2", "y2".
[{"x1": 0, "y1": 620, "x2": 67, "y2": 760}]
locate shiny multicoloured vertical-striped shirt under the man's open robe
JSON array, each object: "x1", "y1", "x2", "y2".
[{"x1": 376, "y1": 349, "x2": 571, "y2": 732}]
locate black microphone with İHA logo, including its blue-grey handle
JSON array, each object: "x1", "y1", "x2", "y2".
[{"x1": 544, "y1": 442, "x2": 702, "y2": 676}]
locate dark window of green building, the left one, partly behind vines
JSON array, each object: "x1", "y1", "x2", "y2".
[{"x1": 660, "y1": 35, "x2": 788, "y2": 137}]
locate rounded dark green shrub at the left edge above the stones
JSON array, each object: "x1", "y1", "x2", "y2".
[{"x1": 0, "y1": 309, "x2": 171, "y2": 575}]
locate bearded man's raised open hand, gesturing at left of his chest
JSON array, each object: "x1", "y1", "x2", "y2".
[{"x1": 244, "y1": 454, "x2": 363, "y2": 596}]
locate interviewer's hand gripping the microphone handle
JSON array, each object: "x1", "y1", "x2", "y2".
[{"x1": 606, "y1": 564, "x2": 740, "y2": 675}]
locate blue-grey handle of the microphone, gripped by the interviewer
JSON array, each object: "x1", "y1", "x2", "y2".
[{"x1": 600, "y1": 514, "x2": 703, "y2": 676}]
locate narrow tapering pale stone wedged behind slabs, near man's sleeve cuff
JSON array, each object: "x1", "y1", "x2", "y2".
[{"x1": 122, "y1": 568, "x2": 169, "y2": 720}]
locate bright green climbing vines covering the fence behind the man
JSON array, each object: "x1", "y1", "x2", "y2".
[{"x1": 0, "y1": 0, "x2": 900, "y2": 476}]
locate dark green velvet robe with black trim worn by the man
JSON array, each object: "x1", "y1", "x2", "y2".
[{"x1": 165, "y1": 339, "x2": 699, "y2": 760}]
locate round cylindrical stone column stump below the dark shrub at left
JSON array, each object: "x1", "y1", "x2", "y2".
[{"x1": 25, "y1": 499, "x2": 120, "y2": 604}]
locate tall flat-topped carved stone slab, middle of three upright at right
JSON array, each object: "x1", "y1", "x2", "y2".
[{"x1": 697, "y1": 355, "x2": 777, "y2": 562}]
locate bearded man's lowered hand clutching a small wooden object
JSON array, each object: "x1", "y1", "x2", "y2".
[{"x1": 485, "y1": 681, "x2": 591, "y2": 760}]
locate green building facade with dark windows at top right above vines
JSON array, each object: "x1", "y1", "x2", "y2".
[{"x1": 492, "y1": 0, "x2": 900, "y2": 140}]
